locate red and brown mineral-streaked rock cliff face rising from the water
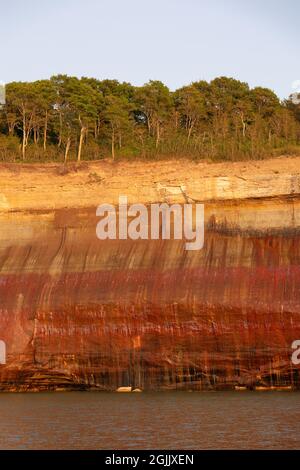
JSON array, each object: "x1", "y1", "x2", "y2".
[{"x1": 0, "y1": 160, "x2": 300, "y2": 390}]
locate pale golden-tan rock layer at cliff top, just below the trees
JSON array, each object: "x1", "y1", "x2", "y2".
[{"x1": 0, "y1": 157, "x2": 300, "y2": 212}]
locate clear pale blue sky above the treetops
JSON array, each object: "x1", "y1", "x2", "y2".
[{"x1": 0, "y1": 0, "x2": 300, "y2": 98}]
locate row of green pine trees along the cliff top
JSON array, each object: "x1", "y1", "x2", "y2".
[{"x1": 0, "y1": 75, "x2": 300, "y2": 162}]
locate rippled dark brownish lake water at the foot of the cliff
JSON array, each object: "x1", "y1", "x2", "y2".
[{"x1": 0, "y1": 392, "x2": 300, "y2": 449}]
